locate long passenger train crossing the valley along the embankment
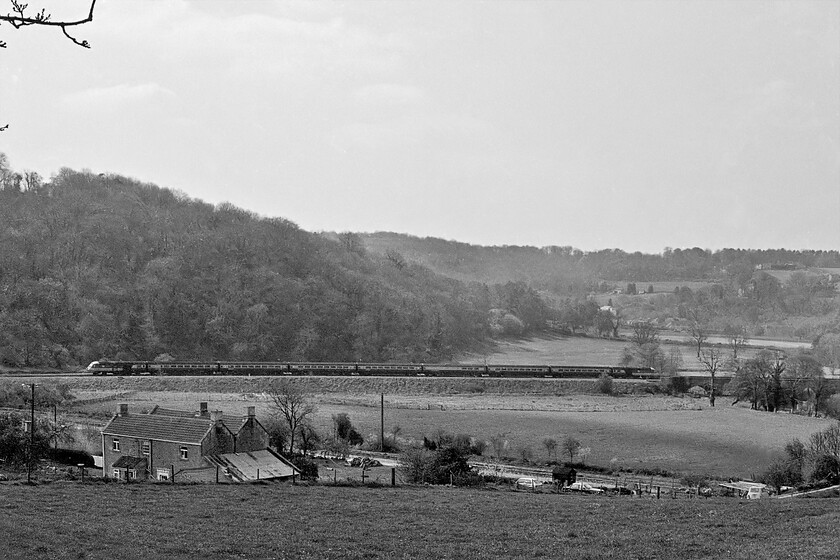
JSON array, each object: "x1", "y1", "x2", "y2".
[{"x1": 87, "y1": 360, "x2": 656, "y2": 379}]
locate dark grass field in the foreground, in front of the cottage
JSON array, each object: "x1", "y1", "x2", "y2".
[{"x1": 0, "y1": 483, "x2": 840, "y2": 560}]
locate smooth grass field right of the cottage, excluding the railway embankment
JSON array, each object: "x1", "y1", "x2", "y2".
[{"x1": 304, "y1": 397, "x2": 829, "y2": 478}]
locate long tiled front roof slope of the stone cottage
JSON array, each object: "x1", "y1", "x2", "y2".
[{"x1": 102, "y1": 414, "x2": 213, "y2": 444}]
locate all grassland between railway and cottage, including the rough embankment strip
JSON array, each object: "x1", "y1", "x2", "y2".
[{"x1": 31, "y1": 377, "x2": 829, "y2": 477}]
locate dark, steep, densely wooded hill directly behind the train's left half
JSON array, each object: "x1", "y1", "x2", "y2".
[{"x1": 0, "y1": 159, "x2": 548, "y2": 367}]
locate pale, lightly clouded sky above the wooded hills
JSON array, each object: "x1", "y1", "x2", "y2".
[{"x1": 0, "y1": 0, "x2": 840, "y2": 253}]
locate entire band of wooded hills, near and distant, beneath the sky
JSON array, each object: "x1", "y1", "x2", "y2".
[{"x1": 0, "y1": 154, "x2": 840, "y2": 367}]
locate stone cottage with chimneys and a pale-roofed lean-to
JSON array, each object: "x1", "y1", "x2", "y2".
[{"x1": 102, "y1": 403, "x2": 297, "y2": 482}]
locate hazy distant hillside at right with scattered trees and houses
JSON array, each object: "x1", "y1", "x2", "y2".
[{"x1": 362, "y1": 233, "x2": 840, "y2": 342}]
